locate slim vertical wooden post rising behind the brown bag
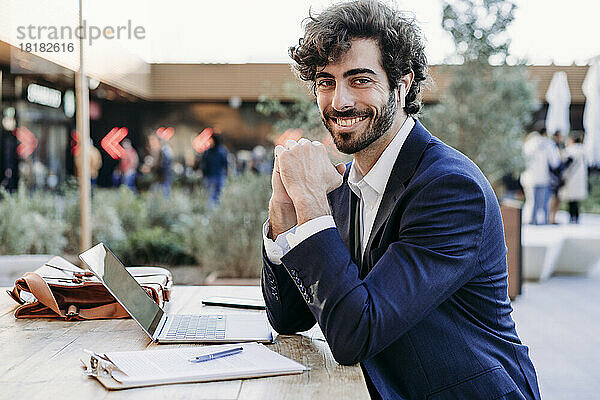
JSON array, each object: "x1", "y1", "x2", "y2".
[{"x1": 75, "y1": 0, "x2": 92, "y2": 252}]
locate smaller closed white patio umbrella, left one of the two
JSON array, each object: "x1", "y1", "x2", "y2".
[{"x1": 546, "y1": 71, "x2": 571, "y2": 137}]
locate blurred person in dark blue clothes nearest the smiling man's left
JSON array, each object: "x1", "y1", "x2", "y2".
[{"x1": 202, "y1": 135, "x2": 228, "y2": 208}]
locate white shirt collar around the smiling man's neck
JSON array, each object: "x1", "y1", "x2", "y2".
[{"x1": 348, "y1": 117, "x2": 415, "y2": 198}]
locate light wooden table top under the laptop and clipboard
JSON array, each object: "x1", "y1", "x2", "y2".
[{"x1": 0, "y1": 286, "x2": 369, "y2": 400}]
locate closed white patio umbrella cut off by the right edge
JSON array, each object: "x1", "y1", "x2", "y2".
[{"x1": 581, "y1": 57, "x2": 600, "y2": 166}]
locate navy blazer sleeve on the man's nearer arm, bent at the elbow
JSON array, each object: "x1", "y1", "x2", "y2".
[{"x1": 282, "y1": 174, "x2": 485, "y2": 364}]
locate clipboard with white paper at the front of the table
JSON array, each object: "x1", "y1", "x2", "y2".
[{"x1": 85, "y1": 343, "x2": 309, "y2": 389}]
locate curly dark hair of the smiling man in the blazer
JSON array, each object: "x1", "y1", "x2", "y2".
[{"x1": 289, "y1": 0, "x2": 429, "y2": 115}]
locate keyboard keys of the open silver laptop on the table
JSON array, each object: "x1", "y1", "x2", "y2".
[{"x1": 166, "y1": 315, "x2": 225, "y2": 340}]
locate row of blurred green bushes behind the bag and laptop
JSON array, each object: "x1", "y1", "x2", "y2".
[{"x1": 0, "y1": 173, "x2": 271, "y2": 277}]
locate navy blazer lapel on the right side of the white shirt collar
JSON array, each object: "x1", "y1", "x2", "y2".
[{"x1": 360, "y1": 117, "x2": 432, "y2": 270}]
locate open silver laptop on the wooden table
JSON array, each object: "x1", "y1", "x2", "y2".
[{"x1": 79, "y1": 243, "x2": 274, "y2": 343}]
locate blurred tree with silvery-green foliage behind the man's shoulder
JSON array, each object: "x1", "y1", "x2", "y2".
[{"x1": 422, "y1": 0, "x2": 537, "y2": 183}]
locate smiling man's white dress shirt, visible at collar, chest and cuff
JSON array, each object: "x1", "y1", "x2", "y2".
[{"x1": 263, "y1": 117, "x2": 415, "y2": 264}]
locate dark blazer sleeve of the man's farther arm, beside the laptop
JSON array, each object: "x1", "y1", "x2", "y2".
[{"x1": 261, "y1": 245, "x2": 316, "y2": 334}]
